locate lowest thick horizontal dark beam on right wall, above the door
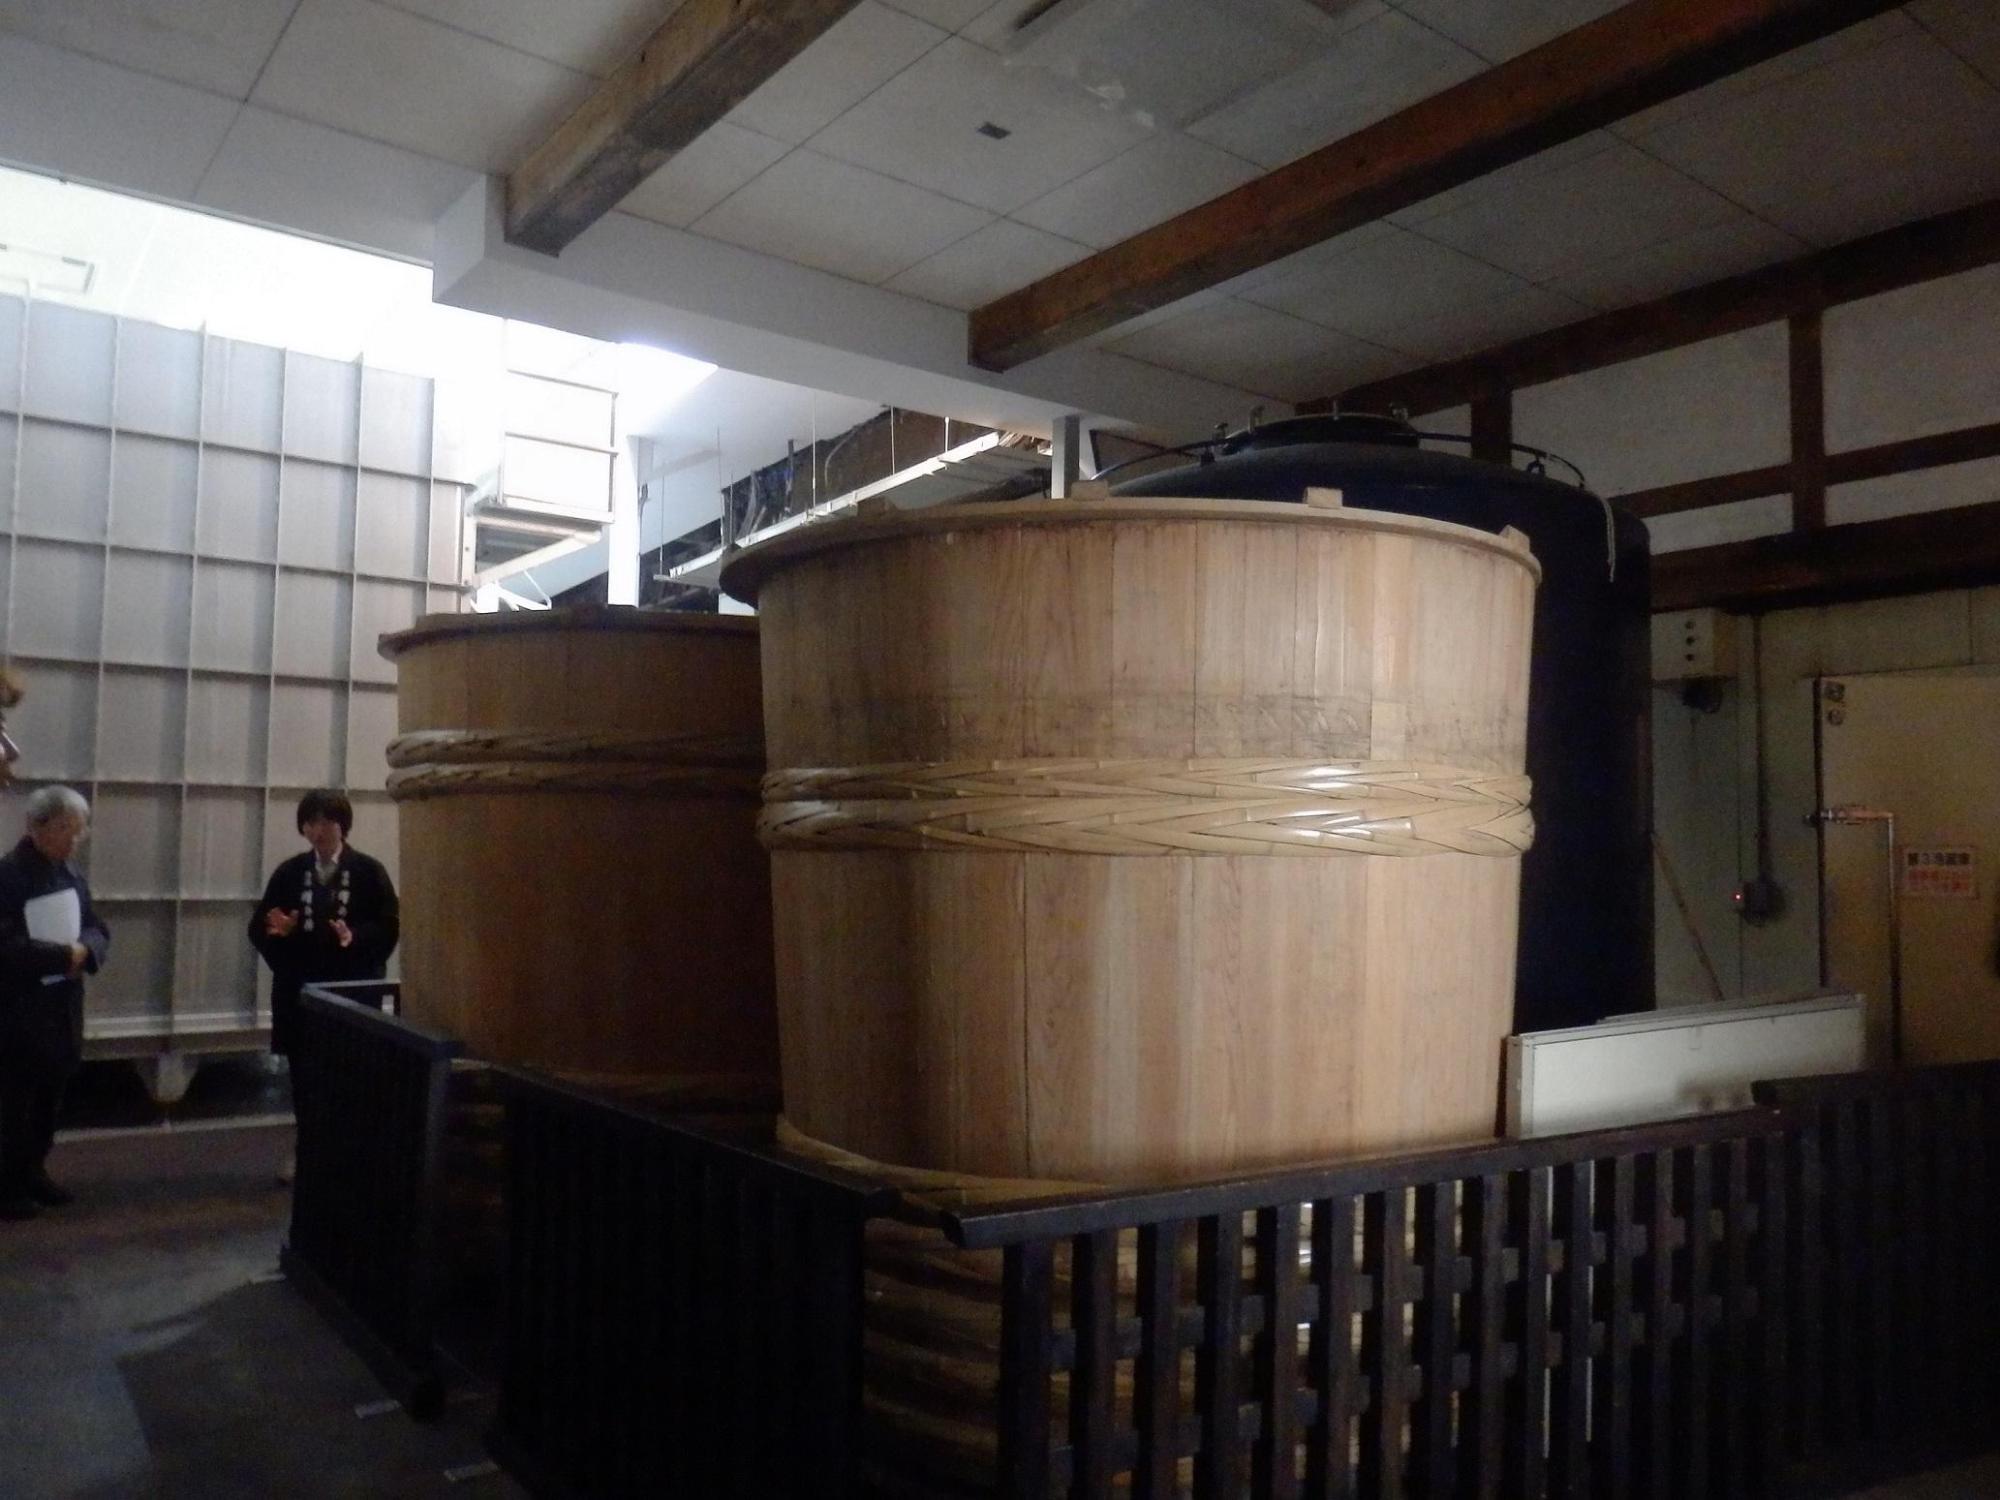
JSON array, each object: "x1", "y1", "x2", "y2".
[{"x1": 1652, "y1": 502, "x2": 2000, "y2": 610}]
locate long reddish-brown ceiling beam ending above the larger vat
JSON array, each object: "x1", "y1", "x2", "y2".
[{"x1": 968, "y1": 0, "x2": 1896, "y2": 370}]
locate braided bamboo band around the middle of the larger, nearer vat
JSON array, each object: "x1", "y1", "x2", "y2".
[{"x1": 758, "y1": 758, "x2": 1534, "y2": 858}]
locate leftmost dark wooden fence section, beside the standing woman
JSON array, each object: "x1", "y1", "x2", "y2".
[{"x1": 280, "y1": 982, "x2": 458, "y2": 1416}]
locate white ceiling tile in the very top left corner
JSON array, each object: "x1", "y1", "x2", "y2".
[{"x1": 0, "y1": 0, "x2": 296, "y2": 100}]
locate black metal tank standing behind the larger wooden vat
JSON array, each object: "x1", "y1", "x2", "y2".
[{"x1": 1112, "y1": 416, "x2": 1654, "y2": 1030}]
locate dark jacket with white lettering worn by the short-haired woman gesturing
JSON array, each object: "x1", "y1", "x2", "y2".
[{"x1": 250, "y1": 844, "x2": 400, "y2": 1052}]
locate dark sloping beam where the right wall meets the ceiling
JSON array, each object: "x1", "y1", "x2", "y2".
[{"x1": 1328, "y1": 200, "x2": 2000, "y2": 416}]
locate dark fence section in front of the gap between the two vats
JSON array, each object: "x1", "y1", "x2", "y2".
[{"x1": 488, "y1": 1072, "x2": 896, "y2": 1500}]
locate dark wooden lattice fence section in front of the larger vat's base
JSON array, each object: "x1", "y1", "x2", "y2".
[{"x1": 948, "y1": 1112, "x2": 1788, "y2": 1500}]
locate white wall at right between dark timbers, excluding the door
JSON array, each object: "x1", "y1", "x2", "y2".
[{"x1": 1504, "y1": 266, "x2": 2000, "y2": 1002}]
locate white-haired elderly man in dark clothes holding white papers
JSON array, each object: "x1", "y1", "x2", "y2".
[{"x1": 0, "y1": 786, "x2": 112, "y2": 1220}]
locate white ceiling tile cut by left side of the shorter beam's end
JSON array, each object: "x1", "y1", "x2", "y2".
[{"x1": 252, "y1": 0, "x2": 594, "y2": 172}]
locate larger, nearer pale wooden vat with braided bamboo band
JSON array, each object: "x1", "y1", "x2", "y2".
[{"x1": 724, "y1": 494, "x2": 1536, "y2": 1182}]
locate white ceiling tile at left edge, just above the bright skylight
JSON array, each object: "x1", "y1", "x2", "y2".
[{"x1": 0, "y1": 36, "x2": 238, "y2": 198}]
